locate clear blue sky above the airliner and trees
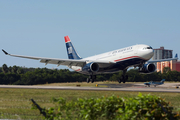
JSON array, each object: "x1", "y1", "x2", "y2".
[{"x1": 0, "y1": 0, "x2": 180, "y2": 69}]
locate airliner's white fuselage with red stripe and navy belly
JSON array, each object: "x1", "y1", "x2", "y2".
[{"x1": 68, "y1": 44, "x2": 154, "y2": 74}]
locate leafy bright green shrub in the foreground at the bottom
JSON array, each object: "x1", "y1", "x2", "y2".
[{"x1": 33, "y1": 93, "x2": 180, "y2": 120}]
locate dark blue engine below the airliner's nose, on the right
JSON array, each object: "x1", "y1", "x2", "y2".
[{"x1": 139, "y1": 63, "x2": 156, "y2": 73}]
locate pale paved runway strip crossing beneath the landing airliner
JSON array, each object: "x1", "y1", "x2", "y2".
[{"x1": 0, "y1": 83, "x2": 180, "y2": 93}]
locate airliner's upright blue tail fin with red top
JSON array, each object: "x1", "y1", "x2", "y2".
[{"x1": 64, "y1": 36, "x2": 82, "y2": 59}]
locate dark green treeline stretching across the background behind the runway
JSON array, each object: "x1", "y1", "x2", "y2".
[{"x1": 0, "y1": 64, "x2": 180, "y2": 85}]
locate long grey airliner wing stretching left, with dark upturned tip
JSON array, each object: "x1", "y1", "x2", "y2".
[{"x1": 2, "y1": 50, "x2": 115, "y2": 67}]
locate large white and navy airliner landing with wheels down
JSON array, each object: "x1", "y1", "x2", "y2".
[{"x1": 2, "y1": 36, "x2": 178, "y2": 83}]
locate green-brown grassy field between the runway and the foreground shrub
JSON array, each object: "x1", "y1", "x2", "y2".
[{"x1": 0, "y1": 83, "x2": 180, "y2": 119}]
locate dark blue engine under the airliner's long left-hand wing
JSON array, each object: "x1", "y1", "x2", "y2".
[{"x1": 82, "y1": 62, "x2": 99, "y2": 72}]
